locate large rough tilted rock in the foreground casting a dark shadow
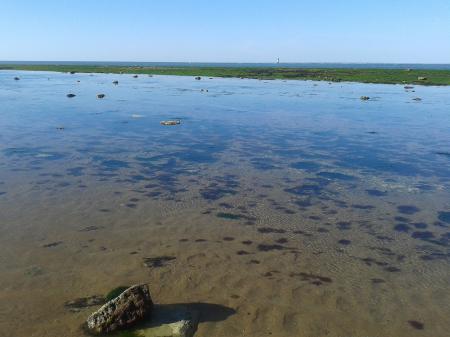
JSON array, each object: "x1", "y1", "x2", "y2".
[{"x1": 86, "y1": 284, "x2": 153, "y2": 334}]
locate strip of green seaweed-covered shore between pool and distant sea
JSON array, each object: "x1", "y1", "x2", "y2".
[{"x1": 0, "y1": 64, "x2": 450, "y2": 85}]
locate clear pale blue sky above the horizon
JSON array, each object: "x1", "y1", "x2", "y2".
[{"x1": 0, "y1": 0, "x2": 450, "y2": 63}]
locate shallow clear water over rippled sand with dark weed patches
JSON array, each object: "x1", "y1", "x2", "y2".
[{"x1": 0, "y1": 71, "x2": 450, "y2": 337}]
